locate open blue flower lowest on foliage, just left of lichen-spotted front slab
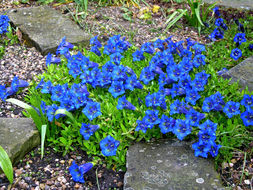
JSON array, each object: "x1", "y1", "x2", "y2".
[{"x1": 100, "y1": 135, "x2": 120, "y2": 156}]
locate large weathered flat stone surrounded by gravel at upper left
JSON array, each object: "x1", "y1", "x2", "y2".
[{"x1": 7, "y1": 6, "x2": 89, "y2": 55}]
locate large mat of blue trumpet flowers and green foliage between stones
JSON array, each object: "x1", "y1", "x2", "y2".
[{"x1": 0, "y1": 1, "x2": 252, "y2": 189}]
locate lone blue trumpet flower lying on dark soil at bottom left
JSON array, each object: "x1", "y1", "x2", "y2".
[{"x1": 69, "y1": 161, "x2": 93, "y2": 183}]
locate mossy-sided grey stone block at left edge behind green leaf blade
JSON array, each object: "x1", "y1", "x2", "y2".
[{"x1": 0, "y1": 118, "x2": 40, "y2": 165}]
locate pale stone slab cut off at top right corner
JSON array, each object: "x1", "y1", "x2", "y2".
[{"x1": 203, "y1": 0, "x2": 253, "y2": 10}]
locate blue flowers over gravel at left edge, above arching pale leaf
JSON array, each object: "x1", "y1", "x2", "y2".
[{"x1": 0, "y1": 76, "x2": 29, "y2": 101}]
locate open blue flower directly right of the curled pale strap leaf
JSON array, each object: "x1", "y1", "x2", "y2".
[{"x1": 82, "y1": 101, "x2": 102, "y2": 121}]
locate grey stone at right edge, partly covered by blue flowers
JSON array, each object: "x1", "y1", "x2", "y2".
[{"x1": 222, "y1": 56, "x2": 253, "y2": 91}]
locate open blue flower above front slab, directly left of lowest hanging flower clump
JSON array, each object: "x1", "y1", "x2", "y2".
[{"x1": 173, "y1": 119, "x2": 192, "y2": 141}]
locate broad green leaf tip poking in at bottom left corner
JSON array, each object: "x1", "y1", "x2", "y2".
[{"x1": 0, "y1": 145, "x2": 13, "y2": 183}]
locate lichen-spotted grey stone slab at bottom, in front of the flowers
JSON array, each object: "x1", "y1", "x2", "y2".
[{"x1": 124, "y1": 139, "x2": 224, "y2": 190}]
